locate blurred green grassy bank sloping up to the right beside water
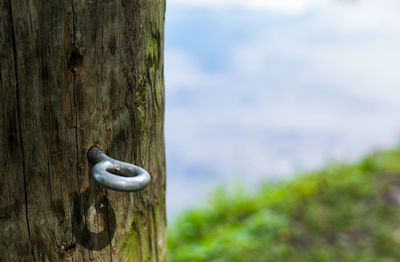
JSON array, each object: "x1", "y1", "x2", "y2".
[{"x1": 168, "y1": 150, "x2": 400, "y2": 262}]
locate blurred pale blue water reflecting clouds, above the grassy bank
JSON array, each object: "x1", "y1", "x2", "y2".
[{"x1": 165, "y1": 0, "x2": 400, "y2": 218}]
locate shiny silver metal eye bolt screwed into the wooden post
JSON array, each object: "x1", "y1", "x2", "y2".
[{"x1": 88, "y1": 147, "x2": 151, "y2": 192}]
